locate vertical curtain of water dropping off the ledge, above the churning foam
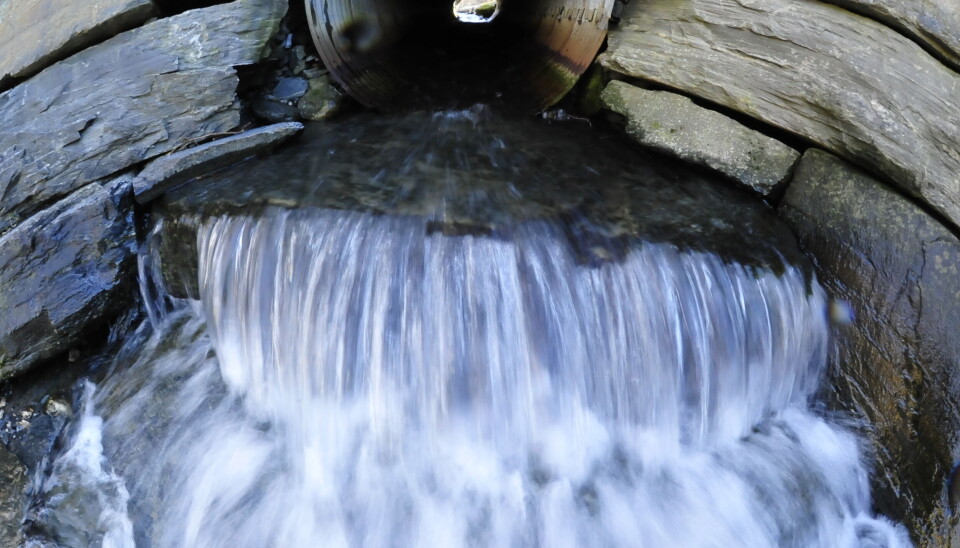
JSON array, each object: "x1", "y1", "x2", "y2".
[{"x1": 199, "y1": 211, "x2": 827, "y2": 448}]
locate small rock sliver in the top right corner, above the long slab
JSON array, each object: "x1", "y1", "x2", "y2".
[{"x1": 827, "y1": 0, "x2": 960, "y2": 70}]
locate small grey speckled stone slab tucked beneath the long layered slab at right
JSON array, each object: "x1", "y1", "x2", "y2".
[{"x1": 601, "y1": 81, "x2": 800, "y2": 196}]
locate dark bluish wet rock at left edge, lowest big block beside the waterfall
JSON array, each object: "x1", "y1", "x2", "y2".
[{"x1": 0, "y1": 177, "x2": 136, "y2": 379}]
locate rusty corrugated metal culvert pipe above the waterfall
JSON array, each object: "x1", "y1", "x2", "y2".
[{"x1": 305, "y1": 0, "x2": 614, "y2": 112}]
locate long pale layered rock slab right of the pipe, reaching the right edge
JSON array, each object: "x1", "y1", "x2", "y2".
[{"x1": 601, "y1": 0, "x2": 960, "y2": 229}]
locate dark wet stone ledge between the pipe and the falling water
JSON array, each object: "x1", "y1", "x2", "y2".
[{"x1": 152, "y1": 109, "x2": 808, "y2": 296}]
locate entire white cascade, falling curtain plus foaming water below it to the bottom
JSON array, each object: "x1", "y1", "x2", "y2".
[{"x1": 20, "y1": 109, "x2": 909, "y2": 548}]
